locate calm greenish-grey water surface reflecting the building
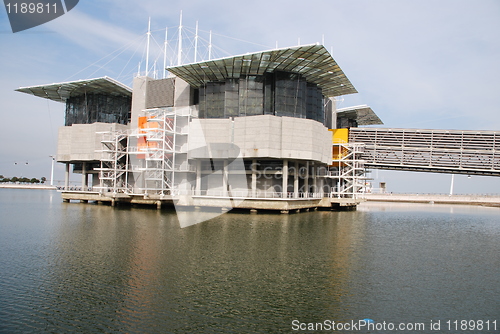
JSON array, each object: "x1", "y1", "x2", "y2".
[{"x1": 0, "y1": 189, "x2": 500, "y2": 333}]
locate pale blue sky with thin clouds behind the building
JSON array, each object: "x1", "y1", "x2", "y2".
[{"x1": 0, "y1": 0, "x2": 500, "y2": 193}]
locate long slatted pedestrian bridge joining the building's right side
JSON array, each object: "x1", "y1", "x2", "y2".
[{"x1": 349, "y1": 128, "x2": 500, "y2": 176}]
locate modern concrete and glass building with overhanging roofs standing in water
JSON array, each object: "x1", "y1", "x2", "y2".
[{"x1": 18, "y1": 44, "x2": 382, "y2": 212}]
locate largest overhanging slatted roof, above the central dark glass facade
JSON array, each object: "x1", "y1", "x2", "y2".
[{"x1": 168, "y1": 44, "x2": 357, "y2": 97}]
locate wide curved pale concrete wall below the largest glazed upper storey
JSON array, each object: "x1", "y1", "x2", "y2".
[{"x1": 189, "y1": 115, "x2": 332, "y2": 163}]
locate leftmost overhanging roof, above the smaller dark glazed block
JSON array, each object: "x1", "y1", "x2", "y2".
[{"x1": 16, "y1": 77, "x2": 132, "y2": 102}]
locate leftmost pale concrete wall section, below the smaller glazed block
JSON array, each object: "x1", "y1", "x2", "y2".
[{"x1": 57, "y1": 123, "x2": 128, "y2": 162}]
